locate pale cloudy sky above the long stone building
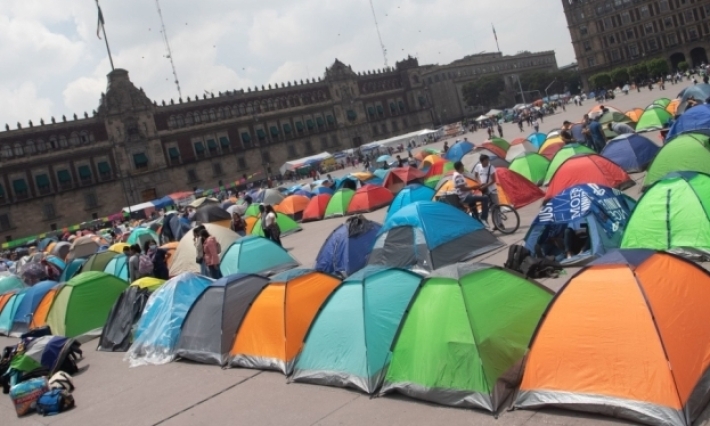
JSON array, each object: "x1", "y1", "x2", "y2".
[{"x1": 0, "y1": 0, "x2": 574, "y2": 128}]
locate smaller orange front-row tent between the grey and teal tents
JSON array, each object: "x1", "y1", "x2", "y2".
[{"x1": 230, "y1": 269, "x2": 341, "y2": 375}]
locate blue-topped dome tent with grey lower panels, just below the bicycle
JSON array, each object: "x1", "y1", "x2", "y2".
[{"x1": 368, "y1": 201, "x2": 503, "y2": 271}]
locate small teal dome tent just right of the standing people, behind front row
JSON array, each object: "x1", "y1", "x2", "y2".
[{"x1": 219, "y1": 236, "x2": 298, "y2": 276}]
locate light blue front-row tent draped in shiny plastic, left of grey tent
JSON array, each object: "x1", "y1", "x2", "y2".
[{"x1": 127, "y1": 272, "x2": 214, "y2": 366}]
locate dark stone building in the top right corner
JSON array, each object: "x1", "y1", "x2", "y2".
[{"x1": 562, "y1": 0, "x2": 710, "y2": 87}]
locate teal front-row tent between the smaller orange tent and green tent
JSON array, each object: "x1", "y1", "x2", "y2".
[{"x1": 291, "y1": 266, "x2": 422, "y2": 394}]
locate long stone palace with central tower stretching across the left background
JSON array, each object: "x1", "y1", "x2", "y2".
[{"x1": 0, "y1": 52, "x2": 556, "y2": 241}]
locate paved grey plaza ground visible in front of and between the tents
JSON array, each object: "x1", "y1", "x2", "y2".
[{"x1": 0, "y1": 85, "x2": 710, "y2": 426}]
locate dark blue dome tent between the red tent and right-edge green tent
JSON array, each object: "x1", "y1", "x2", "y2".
[{"x1": 601, "y1": 133, "x2": 661, "y2": 173}]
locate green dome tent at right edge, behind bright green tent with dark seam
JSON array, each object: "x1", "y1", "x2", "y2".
[{"x1": 643, "y1": 133, "x2": 710, "y2": 188}]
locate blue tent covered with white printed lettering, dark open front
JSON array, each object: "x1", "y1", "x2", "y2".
[{"x1": 525, "y1": 184, "x2": 636, "y2": 265}]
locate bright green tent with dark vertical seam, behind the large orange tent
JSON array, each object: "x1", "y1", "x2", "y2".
[{"x1": 621, "y1": 172, "x2": 710, "y2": 255}]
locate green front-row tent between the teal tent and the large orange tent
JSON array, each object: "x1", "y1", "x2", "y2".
[{"x1": 381, "y1": 264, "x2": 553, "y2": 412}]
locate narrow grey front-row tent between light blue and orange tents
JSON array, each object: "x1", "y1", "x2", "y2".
[{"x1": 175, "y1": 274, "x2": 270, "y2": 366}]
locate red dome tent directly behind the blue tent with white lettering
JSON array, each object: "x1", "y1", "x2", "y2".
[{"x1": 545, "y1": 154, "x2": 636, "y2": 200}]
